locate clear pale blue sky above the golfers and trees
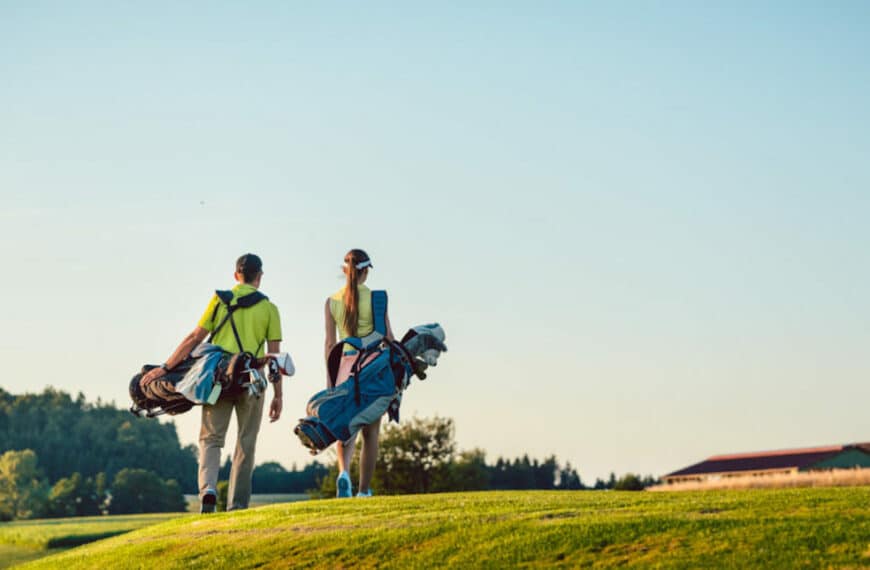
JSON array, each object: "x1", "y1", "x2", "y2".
[{"x1": 0, "y1": 1, "x2": 870, "y2": 482}]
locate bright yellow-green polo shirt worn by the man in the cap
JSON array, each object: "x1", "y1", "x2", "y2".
[{"x1": 199, "y1": 283, "x2": 281, "y2": 356}]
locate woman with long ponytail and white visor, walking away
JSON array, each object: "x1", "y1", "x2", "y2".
[{"x1": 324, "y1": 249, "x2": 393, "y2": 497}]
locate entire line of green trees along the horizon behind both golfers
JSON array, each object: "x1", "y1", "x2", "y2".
[{"x1": 0, "y1": 388, "x2": 656, "y2": 520}]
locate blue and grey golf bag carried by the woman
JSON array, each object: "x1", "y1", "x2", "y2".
[{"x1": 293, "y1": 291, "x2": 447, "y2": 455}]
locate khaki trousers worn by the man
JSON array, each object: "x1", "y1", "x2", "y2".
[{"x1": 199, "y1": 392, "x2": 266, "y2": 510}]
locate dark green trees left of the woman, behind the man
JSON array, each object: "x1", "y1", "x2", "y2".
[{"x1": 0, "y1": 388, "x2": 327, "y2": 520}]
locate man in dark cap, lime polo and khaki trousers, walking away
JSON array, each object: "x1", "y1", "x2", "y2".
[{"x1": 142, "y1": 253, "x2": 282, "y2": 513}]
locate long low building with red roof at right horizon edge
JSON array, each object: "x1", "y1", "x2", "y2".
[{"x1": 662, "y1": 443, "x2": 870, "y2": 484}]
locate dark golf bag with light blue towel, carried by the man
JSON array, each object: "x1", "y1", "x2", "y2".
[{"x1": 129, "y1": 291, "x2": 294, "y2": 412}]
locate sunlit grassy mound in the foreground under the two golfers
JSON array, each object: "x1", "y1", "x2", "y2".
[{"x1": 13, "y1": 487, "x2": 870, "y2": 570}]
